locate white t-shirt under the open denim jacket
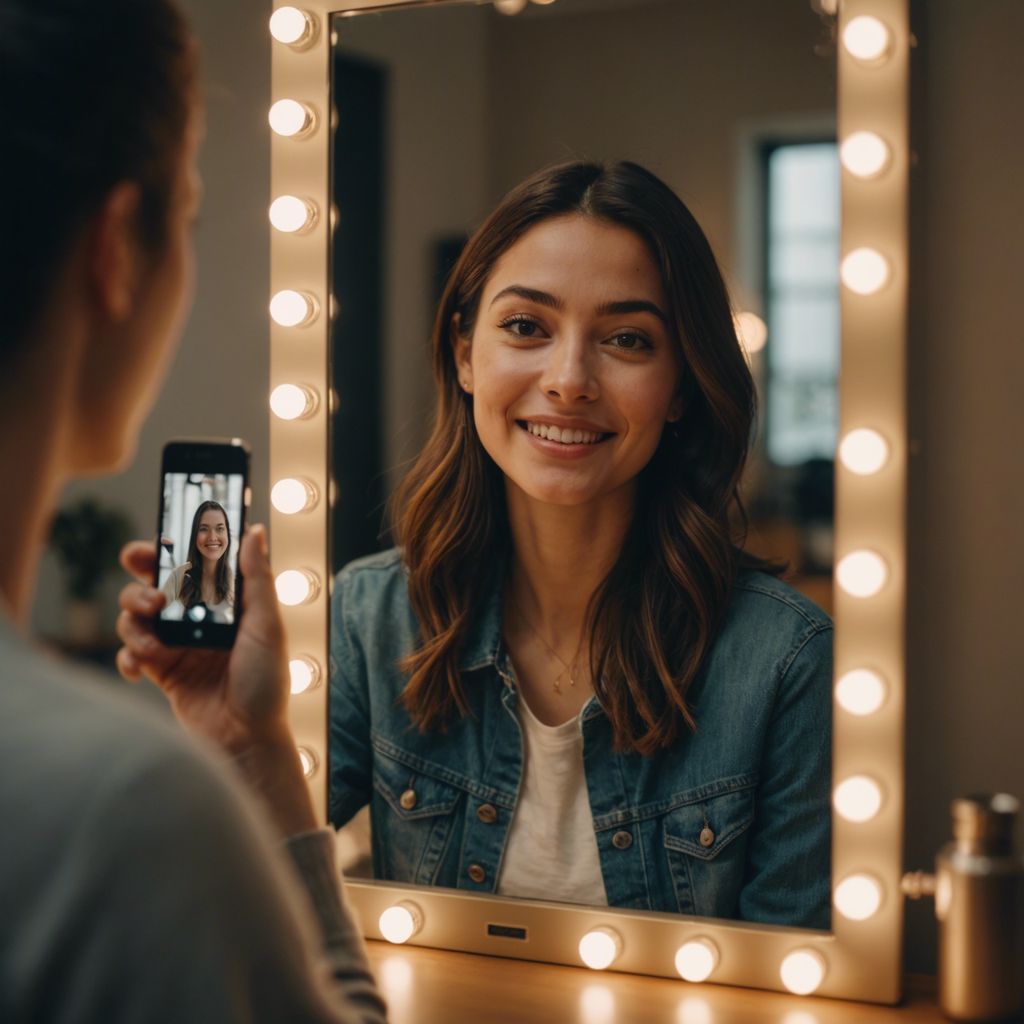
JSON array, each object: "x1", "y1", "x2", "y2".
[{"x1": 498, "y1": 693, "x2": 608, "y2": 906}]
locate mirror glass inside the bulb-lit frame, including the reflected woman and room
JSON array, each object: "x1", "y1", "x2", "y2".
[{"x1": 330, "y1": 0, "x2": 839, "y2": 928}]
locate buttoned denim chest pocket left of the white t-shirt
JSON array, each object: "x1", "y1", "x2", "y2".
[{"x1": 371, "y1": 749, "x2": 464, "y2": 886}]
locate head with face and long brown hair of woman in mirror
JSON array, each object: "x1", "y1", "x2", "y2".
[{"x1": 393, "y1": 162, "x2": 755, "y2": 749}]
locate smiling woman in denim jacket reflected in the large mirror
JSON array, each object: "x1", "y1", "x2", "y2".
[{"x1": 330, "y1": 157, "x2": 831, "y2": 928}]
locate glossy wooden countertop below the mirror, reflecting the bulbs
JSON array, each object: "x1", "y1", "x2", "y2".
[{"x1": 367, "y1": 941, "x2": 944, "y2": 1024}]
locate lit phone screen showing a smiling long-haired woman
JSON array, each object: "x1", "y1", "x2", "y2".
[{"x1": 157, "y1": 473, "x2": 245, "y2": 625}]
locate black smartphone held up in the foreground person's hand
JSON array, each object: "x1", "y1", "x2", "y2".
[{"x1": 154, "y1": 437, "x2": 252, "y2": 647}]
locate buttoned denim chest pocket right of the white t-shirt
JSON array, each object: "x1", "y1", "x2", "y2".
[{"x1": 662, "y1": 775, "x2": 754, "y2": 918}]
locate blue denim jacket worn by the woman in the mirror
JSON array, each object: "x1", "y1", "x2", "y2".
[{"x1": 330, "y1": 549, "x2": 833, "y2": 929}]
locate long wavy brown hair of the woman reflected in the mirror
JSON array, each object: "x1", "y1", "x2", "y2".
[{"x1": 391, "y1": 162, "x2": 774, "y2": 755}]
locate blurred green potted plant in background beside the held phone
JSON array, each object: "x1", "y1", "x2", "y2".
[{"x1": 50, "y1": 498, "x2": 132, "y2": 644}]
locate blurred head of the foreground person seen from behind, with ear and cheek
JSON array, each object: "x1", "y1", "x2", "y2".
[{"x1": 0, "y1": 0, "x2": 200, "y2": 473}]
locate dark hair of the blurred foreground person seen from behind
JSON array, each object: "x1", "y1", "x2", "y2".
[{"x1": 0, "y1": 0, "x2": 197, "y2": 350}]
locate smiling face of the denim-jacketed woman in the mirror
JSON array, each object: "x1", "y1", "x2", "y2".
[{"x1": 456, "y1": 214, "x2": 681, "y2": 506}]
